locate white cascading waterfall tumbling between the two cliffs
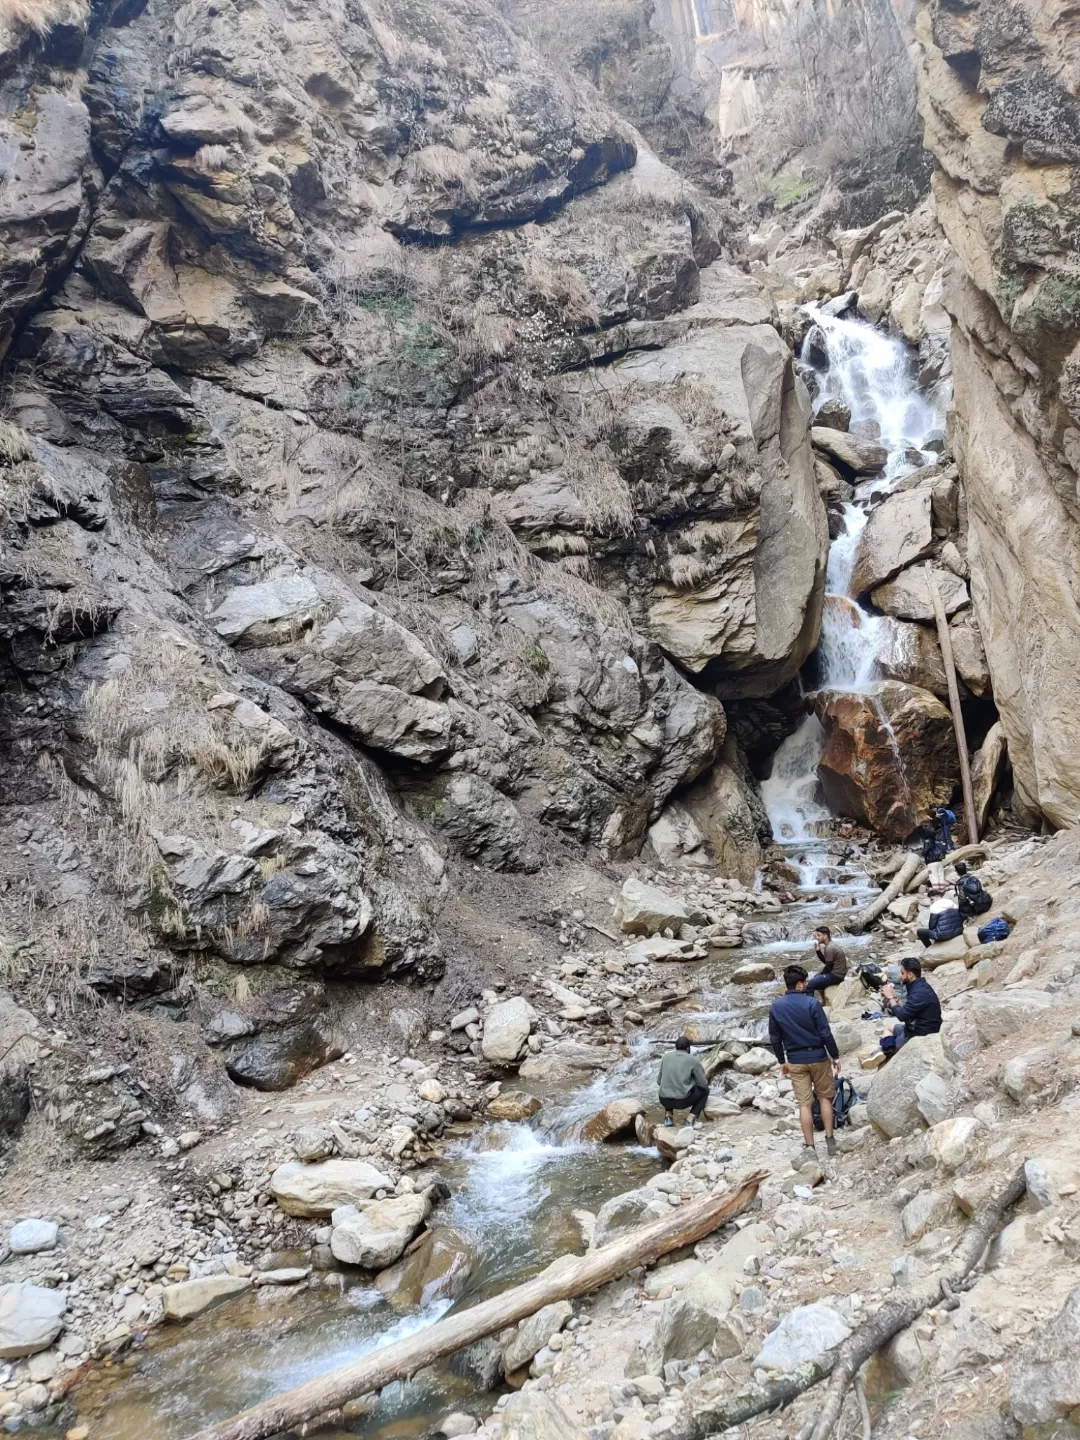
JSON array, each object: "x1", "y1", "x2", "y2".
[{"x1": 762, "y1": 305, "x2": 946, "y2": 840}]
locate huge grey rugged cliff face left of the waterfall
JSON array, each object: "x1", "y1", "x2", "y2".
[{"x1": 0, "y1": 0, "x2": 828, "y2": 1036}]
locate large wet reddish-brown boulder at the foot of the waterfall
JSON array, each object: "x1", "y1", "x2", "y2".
[{"x1": 814, "y1": 680, "x2": 959, "y2": 840}]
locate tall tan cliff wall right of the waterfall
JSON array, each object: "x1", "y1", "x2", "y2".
[{"x1": 917, "y1": 0, "x2": 1080, "y2": 825}]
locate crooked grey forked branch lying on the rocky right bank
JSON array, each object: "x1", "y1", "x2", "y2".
[{"x1": 670, "y1": 1165, "x2": 1027, "y2": 1440}]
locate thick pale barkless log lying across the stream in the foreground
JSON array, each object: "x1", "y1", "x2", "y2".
[{"x1": 190, "y1": 1171, "x2": 768, "y2": 1440}]
